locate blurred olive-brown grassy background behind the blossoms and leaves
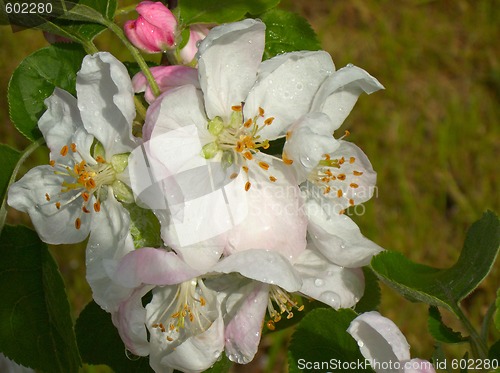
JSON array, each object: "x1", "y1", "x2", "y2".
[{"x1": 0, "y1": 0, "x2": 500, "y2": 372}]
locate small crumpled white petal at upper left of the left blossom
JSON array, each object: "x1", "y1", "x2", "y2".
[{"x1": 38, "y1": 88, "x2": 83, "y2": 162}]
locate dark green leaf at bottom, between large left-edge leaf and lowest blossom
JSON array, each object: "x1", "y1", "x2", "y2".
[{"x1": 75, "y1": 301, "x2": 153, "y2": 373}]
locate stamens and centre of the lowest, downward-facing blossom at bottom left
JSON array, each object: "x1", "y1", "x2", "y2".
[{"x1": 151, "y1": 279, "x2": 213, "y2": 342}]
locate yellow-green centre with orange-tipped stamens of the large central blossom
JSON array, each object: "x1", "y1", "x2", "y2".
[{"x1": 202, "y1": 103, "x2": 276, "y2": 191}]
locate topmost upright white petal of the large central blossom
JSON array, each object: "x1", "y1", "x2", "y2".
[{"x1": 198, "y1": 19, "x2": 265, "y2": 122}]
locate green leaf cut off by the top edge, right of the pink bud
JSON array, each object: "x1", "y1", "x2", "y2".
[{"x1": 179, "y1": 0, "x2": 280, "y2": 25}]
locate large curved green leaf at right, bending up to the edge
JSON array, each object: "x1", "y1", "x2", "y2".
[{"x1": 371, "y1": 211, "x2": 500, "y2": 315}]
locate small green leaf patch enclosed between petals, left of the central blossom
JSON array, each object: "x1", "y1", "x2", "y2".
[{"x1": 123, "y1": 204, "x2": 163, "y2": 249}]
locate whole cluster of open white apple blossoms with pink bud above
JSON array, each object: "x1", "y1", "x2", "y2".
[{"x1": 4, "y1": 7, "x2": 406, "y2": 372}]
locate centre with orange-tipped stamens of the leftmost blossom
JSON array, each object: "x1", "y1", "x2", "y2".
[{"x1": 45, "y1": 143, "x2": 116, "y2": 229}]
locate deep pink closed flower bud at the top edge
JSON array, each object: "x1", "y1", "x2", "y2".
[{"x1": 124, "y1": 1, "x2": 177, "y2": 53}]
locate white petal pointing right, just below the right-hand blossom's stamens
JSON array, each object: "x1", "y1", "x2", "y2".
[{"x1": 305, "y1": 198, "x2": 383, "y2": 268}]
